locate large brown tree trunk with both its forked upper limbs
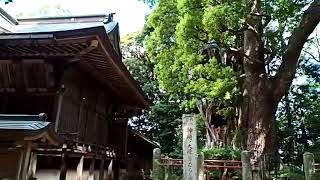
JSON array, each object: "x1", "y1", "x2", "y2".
[{"x1": 243, "y1": 0, "x2": 320, "y2": 168}]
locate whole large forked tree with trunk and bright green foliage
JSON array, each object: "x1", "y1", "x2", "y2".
[{"x1": 146, "y1": 0, "x2": 320, "y2": 172}]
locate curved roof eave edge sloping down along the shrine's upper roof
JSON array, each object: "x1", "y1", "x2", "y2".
[{"x1": 0, "y1": 23, "x2": 149, "y2": 109}]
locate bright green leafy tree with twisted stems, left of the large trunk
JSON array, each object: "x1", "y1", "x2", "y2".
[{"x1": 146, "y1": 0, "x2": 242, "y2": 150}]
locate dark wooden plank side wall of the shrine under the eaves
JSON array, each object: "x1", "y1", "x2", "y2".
[{"x1": 61, "y1": 68, "x2": 110, "y2": 145}]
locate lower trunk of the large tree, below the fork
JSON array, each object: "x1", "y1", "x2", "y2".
[{"x1": 247, "y1": 83, "x2": 278, "y2": 163}]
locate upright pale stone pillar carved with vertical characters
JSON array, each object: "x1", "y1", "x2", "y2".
[{"x1": 182, "y1": 114, "x2": 198, "y2": 180}]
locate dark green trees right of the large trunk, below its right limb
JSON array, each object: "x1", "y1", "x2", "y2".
[{"x1": 278, "y1": 33, "x2": 320, "y2": 165}]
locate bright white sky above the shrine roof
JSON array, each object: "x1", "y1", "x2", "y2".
[{"x1": 0, "y1": 0, "x2": 150, "y2": 36}]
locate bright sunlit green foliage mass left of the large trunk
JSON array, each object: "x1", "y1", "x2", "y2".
[{"x1": 145, "y1": 0, "x2": 241, "y2": 119}]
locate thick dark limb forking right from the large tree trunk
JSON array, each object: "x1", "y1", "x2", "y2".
[{"x1": 273, "y1": 0, "x2": 320, "y2": 100}]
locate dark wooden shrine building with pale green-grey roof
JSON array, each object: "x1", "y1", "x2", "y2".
[{"x1": 0, "y1": 10, "x2": 154, "y2": 180}]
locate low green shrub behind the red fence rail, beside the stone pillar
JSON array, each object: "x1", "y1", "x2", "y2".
[{"x1": 202, "y1": 146, "x2": 241, "y2": 160}]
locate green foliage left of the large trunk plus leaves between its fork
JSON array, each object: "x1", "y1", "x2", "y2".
[{"x1": 145, "y1": 0, "x2": 307, "y2": 109}]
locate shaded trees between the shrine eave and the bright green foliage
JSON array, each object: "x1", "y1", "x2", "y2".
[{"x1": 121, "y1": 28, "x2": 183, "y2": 155}]
